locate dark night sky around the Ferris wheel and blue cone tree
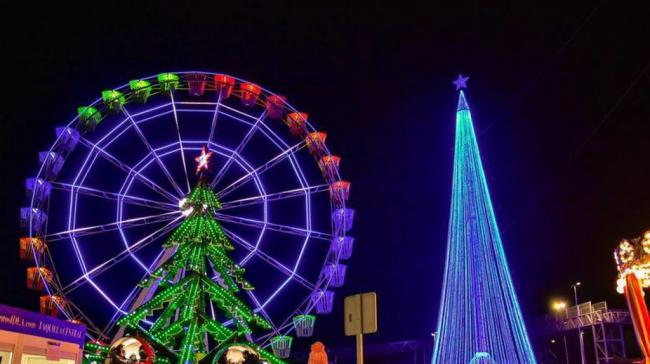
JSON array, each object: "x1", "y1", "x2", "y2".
[{"x1": 0, "y1": 1, "x2": 650, "y2": 356}]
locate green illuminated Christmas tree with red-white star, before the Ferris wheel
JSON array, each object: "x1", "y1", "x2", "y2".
[{"x1": 118, "y1": 148, "x2": 282, "y2": 364}]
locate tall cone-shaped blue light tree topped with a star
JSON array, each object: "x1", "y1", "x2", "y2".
[{"x1": 433, "y1": 75, "x2": 536, "y2": 364}]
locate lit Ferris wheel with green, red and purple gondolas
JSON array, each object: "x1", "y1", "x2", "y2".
[{"x1": 20, "y1": 71, "x2": 354, "y2": 352}]
